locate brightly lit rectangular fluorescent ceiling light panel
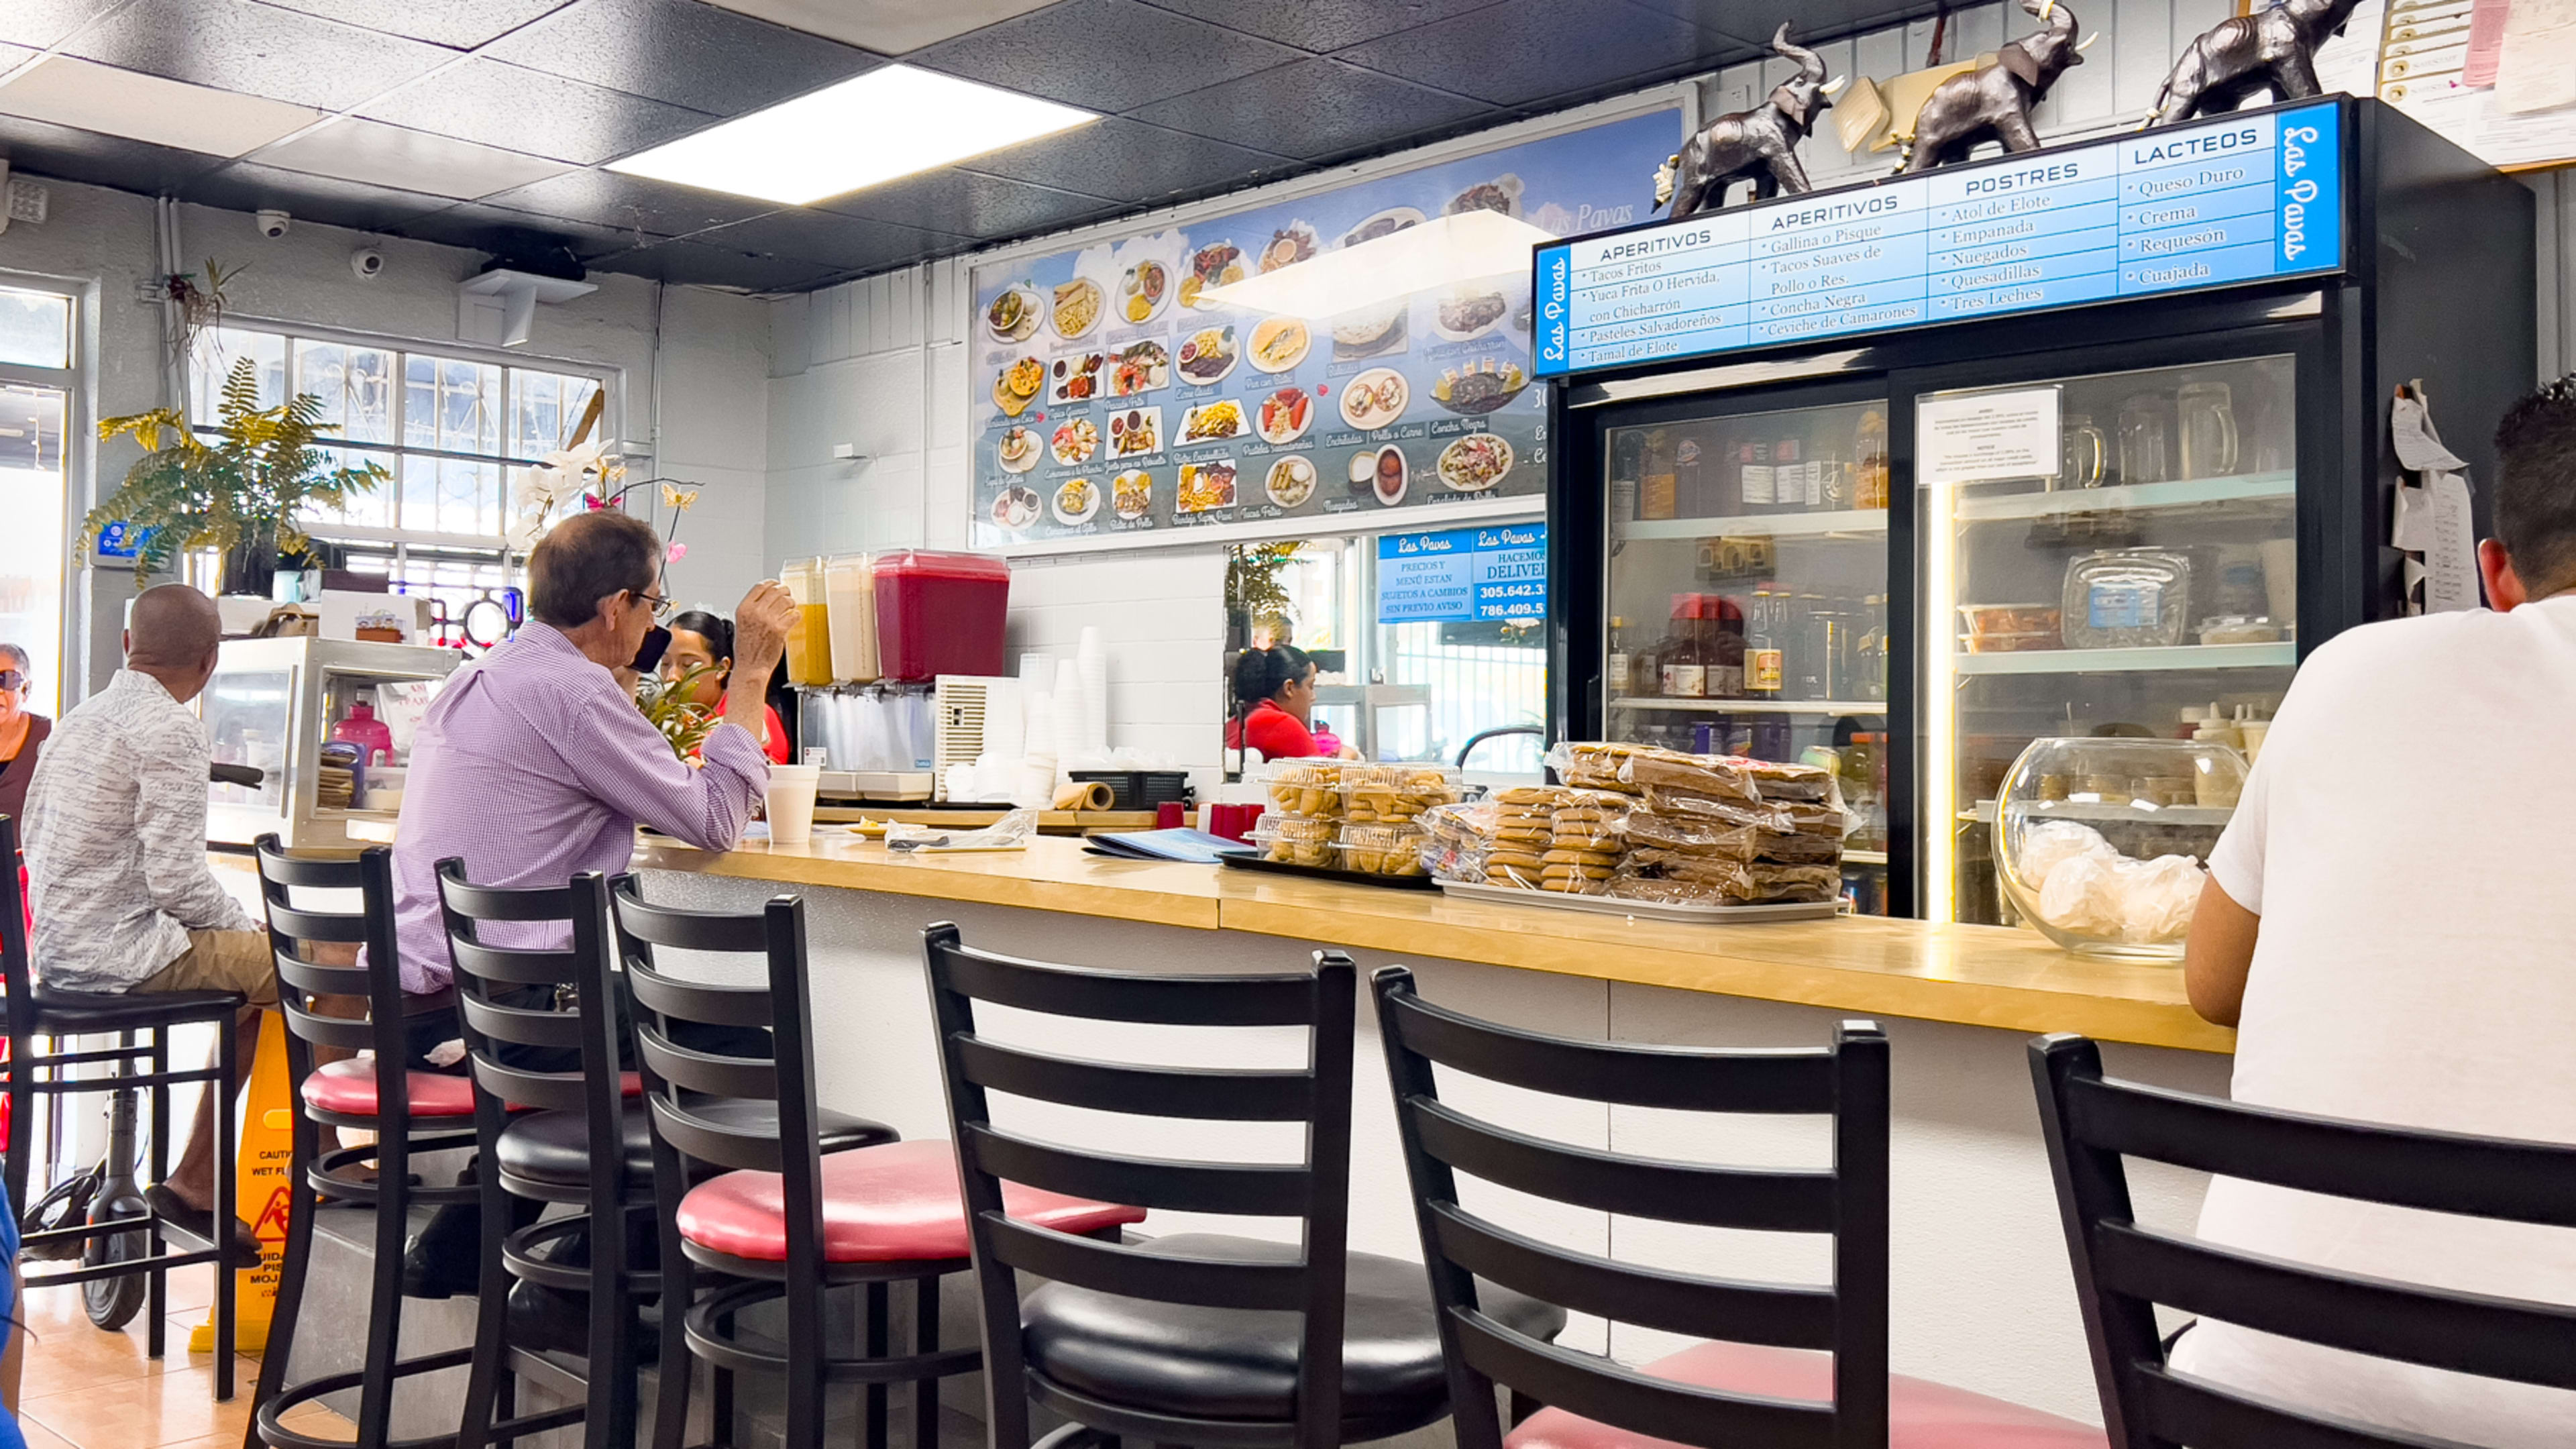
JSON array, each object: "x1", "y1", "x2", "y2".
[{"x1": 608, "y1": 64, "x2": 1100, "y2": 206}]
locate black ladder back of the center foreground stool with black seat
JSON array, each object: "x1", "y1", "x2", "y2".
[{"x1": 925, "y1": 923, "x2": 1358, "y2": 1449}]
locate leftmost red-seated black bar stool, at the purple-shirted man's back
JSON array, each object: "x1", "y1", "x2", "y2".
[{"x1": 245, "y1": 835, "x2": 479, "y2": 1449}]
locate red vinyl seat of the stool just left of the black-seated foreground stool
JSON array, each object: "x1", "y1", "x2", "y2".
[{"x1": 678, "y1": 1140, "x2": 1144, "y2": 1263}]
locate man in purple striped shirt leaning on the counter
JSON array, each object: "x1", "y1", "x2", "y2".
[{"x1": 394, "y1": 511, "x2": 796, "y2": 989}]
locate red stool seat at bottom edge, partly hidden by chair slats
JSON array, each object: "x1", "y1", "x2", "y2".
[{"x1": 1505, "y1": 1343, "x2": 2110, "y2": 1449}]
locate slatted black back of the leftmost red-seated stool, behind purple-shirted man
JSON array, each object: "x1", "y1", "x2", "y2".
[{"x1": 255, "y1": 835, "x2": 427, "y2": 1108}]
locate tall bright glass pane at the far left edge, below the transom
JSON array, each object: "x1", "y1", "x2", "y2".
[{"x1": 0, "y1": 382, "x2": 70, "y2": 716}]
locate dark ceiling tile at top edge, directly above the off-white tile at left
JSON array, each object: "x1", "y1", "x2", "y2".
[{"x1": 64, "y1": 0, "x2": 456, "y2": 111}]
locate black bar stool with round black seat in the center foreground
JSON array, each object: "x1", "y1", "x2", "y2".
[{"x1": 925, "y1": 926, "x2": 1566, "y2": 1449}]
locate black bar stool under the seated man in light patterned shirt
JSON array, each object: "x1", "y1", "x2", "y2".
[{"x1": 0, "y1": 815, "x2": 252, "y2": 1400}]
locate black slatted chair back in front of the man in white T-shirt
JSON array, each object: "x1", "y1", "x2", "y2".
[{"x1": 2030, "y1": 1034, "x2": 2576, "y2": 1449}]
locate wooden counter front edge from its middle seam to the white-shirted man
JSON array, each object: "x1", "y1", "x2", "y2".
[{"x1": 1218, "y1": 900, "x2": 2236, "y2": 1055}]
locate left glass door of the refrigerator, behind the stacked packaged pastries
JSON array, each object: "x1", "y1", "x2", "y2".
[{"x1": 1600, "y1": 397, "x2": 1888, "y2": 913}]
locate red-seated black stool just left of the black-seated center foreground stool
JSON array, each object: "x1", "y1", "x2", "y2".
[{"x1": 608, "y1": 877, "x2": 1010, "y2": 1449}]
